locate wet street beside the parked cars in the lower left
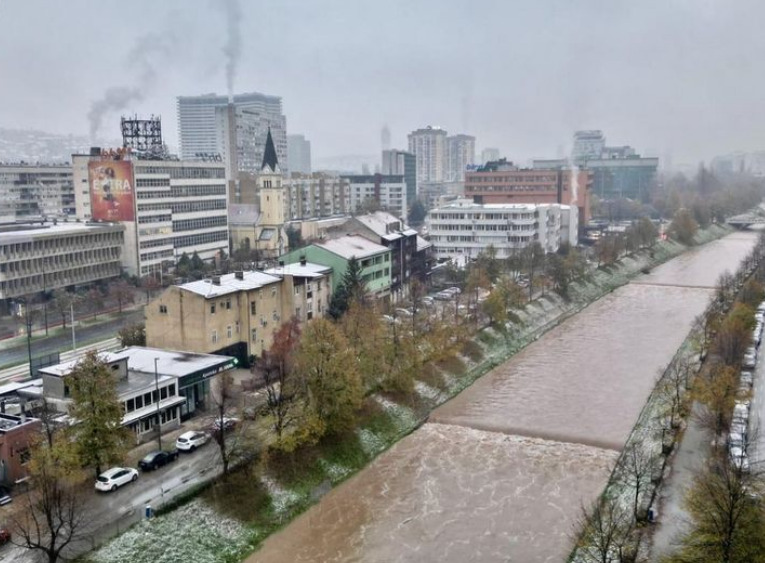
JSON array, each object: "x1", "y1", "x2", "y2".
[{"x1": 0, "y1": 441, "x2": 222, "y2": 563}]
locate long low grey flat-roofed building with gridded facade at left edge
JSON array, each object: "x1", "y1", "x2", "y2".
[{"x1": 0, "y1": 222, "x2": 125, "y2": 301}]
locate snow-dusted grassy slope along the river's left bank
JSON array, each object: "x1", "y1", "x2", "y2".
[{"x1": 80, "y1": 226, "x2": 730, "y2": 563}]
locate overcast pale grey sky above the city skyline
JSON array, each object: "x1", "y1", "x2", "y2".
[{"x1": 0, "y1": 0, "x2": 765, "y2": 162}]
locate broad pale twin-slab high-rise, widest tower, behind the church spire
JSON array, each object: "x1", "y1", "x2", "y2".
[{"x1": 177, "y1": 92, "x2": 289, "y2": 173}]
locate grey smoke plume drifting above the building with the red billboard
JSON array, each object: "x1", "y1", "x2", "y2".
[{"x1": 88, "y1": 33, "x2": 175, "y2": 143}]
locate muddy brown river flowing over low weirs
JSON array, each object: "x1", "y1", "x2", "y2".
[{"x1": 247, "y1": 232, "x2": 756, "y2": 563}]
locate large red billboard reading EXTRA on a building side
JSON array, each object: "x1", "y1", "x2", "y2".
[{"x1": 88, "y1": 160, "x2": 135, "y2": 221}]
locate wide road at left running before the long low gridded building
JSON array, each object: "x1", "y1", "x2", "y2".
[{"x1": 0, "y1": 308, "x2": 143, "y2": 368}]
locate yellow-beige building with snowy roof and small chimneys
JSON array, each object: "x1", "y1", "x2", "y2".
[{"x1": 146, "y1": 262, "x2": 332, "y2": 364}]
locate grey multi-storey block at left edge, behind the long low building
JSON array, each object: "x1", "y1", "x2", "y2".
[{"x1": 0, "y1": 164, "x2": 75, "y2": 222}]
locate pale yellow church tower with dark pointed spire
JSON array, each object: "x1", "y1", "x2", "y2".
[{"x1": 258, "y1": 127, "x2": 287, "y2": 255}]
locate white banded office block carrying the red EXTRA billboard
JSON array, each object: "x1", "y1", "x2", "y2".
[{"x1": 72, "y1": 147, "x2": 229, "y2": 276}]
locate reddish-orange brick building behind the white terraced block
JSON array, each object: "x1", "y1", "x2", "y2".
[{"x1": 465, "y1": 159, "x2": 592, "y2": 225}]
